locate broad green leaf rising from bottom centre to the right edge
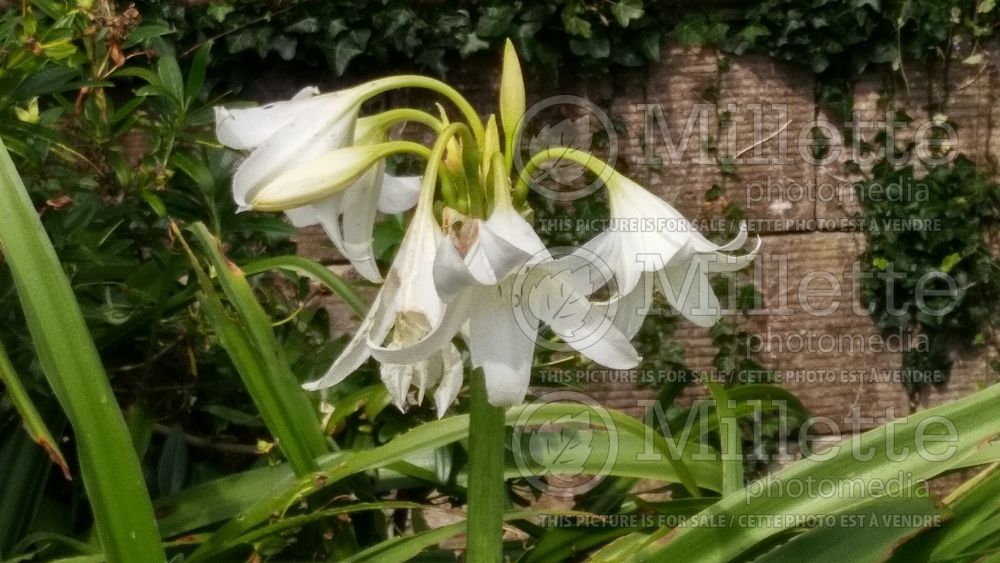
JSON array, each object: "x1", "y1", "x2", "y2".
[{"x1": 630, "y1": 385, "x2": 1000, "y2": 561}]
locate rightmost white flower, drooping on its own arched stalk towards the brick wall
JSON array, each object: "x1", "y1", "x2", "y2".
[{"x1": 584, "y1": 172, "x2": 760, "y2": 328}]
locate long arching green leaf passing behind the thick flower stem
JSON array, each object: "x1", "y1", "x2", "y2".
[{"x1": 188, "y1": 403, "x2": 720, "y2": 563}]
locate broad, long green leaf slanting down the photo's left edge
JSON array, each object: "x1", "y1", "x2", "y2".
[{"x1": 0, "y1": 138, "x2": 164, "y2": 563}]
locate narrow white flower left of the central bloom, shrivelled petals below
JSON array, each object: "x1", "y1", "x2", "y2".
[{"x1": 303, "y1": 182, "x2": 464, "y2": 417}]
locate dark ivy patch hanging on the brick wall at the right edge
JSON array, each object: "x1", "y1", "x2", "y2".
[{"x1": 855, "y1": 156, "x2": 1000, "y2": 396}]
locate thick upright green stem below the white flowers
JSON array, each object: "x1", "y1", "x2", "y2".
[{"x1": 467, "y1": 370, "x2": 507, "y2": 561}]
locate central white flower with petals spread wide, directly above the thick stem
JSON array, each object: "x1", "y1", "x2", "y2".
[{"x1": 373, "y1": 186, "x2": 639, "y2": 406}]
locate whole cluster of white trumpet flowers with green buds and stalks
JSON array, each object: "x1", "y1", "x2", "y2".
[{"x1": 216, "y1": 39, "x2": 756, "y2": 416}]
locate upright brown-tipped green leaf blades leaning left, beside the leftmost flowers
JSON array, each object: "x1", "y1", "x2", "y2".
[{"x1": 174, "y1": 223, "x2": 327, "y2": 475}]
